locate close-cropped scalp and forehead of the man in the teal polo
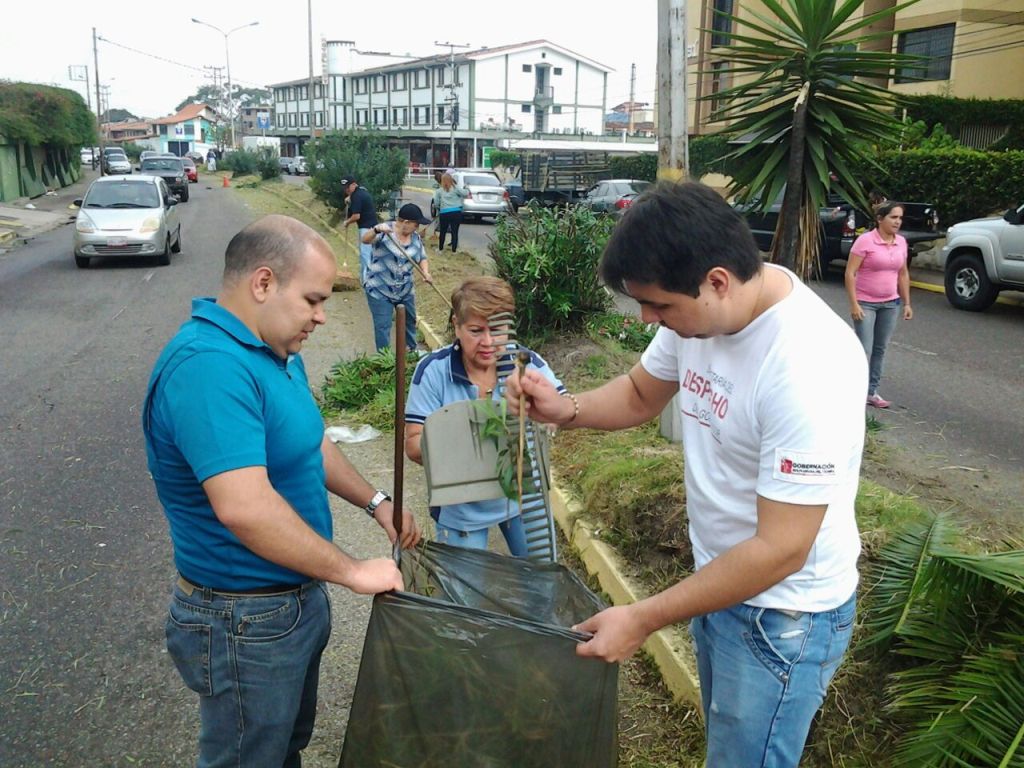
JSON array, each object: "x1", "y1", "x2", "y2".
[{"x1": 224, "y1": 214, "x2": 334, "y2": 286}]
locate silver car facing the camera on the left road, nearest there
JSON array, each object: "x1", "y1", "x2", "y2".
[{"x1": 74, "y1": 175, "x2": 181, "y2": 269}]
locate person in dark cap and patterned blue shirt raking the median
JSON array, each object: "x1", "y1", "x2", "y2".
[{"x1": 362, "y1": 203, "x2": 433, "y2": 352}]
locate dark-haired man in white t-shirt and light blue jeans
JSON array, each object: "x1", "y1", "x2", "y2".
[{"x1": 508, "y1": 183, "x2": 867, "y2": 768}]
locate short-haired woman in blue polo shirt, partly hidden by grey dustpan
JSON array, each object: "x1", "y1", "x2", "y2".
[{"x1": 406, "y1": 276, "x2": 565, "y2": 557}]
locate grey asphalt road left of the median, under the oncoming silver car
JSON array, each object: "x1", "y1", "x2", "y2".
[{"x1": 0, "y1": 181, "x2": 403, "y2": 768}]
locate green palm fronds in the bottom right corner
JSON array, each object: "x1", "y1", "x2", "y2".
[{"x1": 865, "y1": 517, "x2": 1024, "y2": 768}]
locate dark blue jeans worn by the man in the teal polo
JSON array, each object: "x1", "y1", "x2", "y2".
[{"x1": 166, "y1": 582, "x2": 331, "y2": 768}]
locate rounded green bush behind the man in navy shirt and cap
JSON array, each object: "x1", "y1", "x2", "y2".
[{"x1": 306, "y1": 130, "x2": 409, "y2": 210}]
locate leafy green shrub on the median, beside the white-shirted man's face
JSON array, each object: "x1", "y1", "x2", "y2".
[{"x1": 490, "y1": 206, "x2": 614, "y2": 344}]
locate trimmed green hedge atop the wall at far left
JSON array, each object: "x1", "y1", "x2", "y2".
[{"x1": 0, "y1": 82, "x2": 96, "y2": 146}]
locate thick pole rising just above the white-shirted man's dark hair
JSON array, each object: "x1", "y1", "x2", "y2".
[{"x1": 657, "y1": 0, "x2": 689, "y2": 181}]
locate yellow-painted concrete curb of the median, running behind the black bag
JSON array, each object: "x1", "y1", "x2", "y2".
[{"x1": 417, "y1": 319, "x2": 700, "y2": 710}]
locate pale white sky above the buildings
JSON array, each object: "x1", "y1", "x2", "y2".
[{"x1": 0, "y1": 0, "x2": 657, "y2": 118}]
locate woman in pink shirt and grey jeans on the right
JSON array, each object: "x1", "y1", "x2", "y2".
[{"x1": 846, "y1": 202, "x2": 913, "y2": 408}]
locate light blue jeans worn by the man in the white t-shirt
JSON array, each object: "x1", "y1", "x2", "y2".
[{"x1": 690, "y1": 596, "x2": 856, "y2": 768}]
